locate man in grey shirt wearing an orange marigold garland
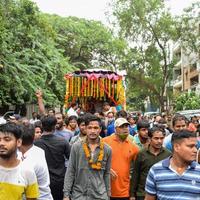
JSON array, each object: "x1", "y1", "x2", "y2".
[{"x1": 63, "y1": 115, "x2": 111, "y2": 200}]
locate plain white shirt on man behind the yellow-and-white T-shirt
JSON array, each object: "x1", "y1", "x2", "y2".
[{"x1": 18, "y1": 145, "x2": 53, "y2": 200}]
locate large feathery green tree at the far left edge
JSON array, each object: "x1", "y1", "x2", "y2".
[{"x1": 0, "y1": 0, "x2": 71, "y2": 109}]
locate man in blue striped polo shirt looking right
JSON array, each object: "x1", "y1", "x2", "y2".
[{"x1": 145, "y1": 130, "x2": 200, "y2": 200}]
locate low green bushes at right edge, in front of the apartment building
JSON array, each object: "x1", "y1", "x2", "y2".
[{"x1": 175, "y1": 92, "x2": 200, "y2": 111}]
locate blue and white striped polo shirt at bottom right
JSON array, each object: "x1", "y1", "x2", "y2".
[{"x1": 145, "y1": 158, "x2": 200, "y2": 200}]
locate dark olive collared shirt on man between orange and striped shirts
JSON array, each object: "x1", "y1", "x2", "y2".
[{"x1": 131, "y1": 147, "x2": 171, "y2": 196}]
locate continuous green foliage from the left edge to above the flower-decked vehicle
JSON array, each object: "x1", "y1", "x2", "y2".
[{"x1": 0, "y1": 0, "x2": 126, "y2": 109}]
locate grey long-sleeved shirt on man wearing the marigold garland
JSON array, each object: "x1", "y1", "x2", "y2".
[{"x1": 63, "y1": 139, "x2": 111, "y2": 200}]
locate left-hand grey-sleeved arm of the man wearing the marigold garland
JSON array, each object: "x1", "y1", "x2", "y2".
[{"x1": 63, "y1": 145, "x2": 76, "y2": 200}]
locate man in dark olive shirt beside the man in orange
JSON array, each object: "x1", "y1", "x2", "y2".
[{"x1": 131, "y1": 127, "x2": 171, "y2": 200}]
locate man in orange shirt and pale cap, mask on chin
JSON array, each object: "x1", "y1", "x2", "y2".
[{"x1": 103, "y1": 118, "x2": 139, "y2": 200}]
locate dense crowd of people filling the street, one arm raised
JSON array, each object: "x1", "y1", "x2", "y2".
[{"x1": 0, "y1": 94, "x2": 200, "y2": 200}]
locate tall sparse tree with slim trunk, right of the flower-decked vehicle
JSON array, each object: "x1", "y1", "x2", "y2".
[{"x1": 113, "y1": 0, "x2": 177, "y2": 111}]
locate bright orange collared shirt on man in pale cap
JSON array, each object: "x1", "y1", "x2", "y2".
[{"x1": 103, "y1": 134, "x2": 139, "y2": 198}]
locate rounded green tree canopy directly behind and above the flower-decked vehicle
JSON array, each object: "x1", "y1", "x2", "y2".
[{"x1": 46, "y1": 15, "x2": 127, "y2": 70}]
